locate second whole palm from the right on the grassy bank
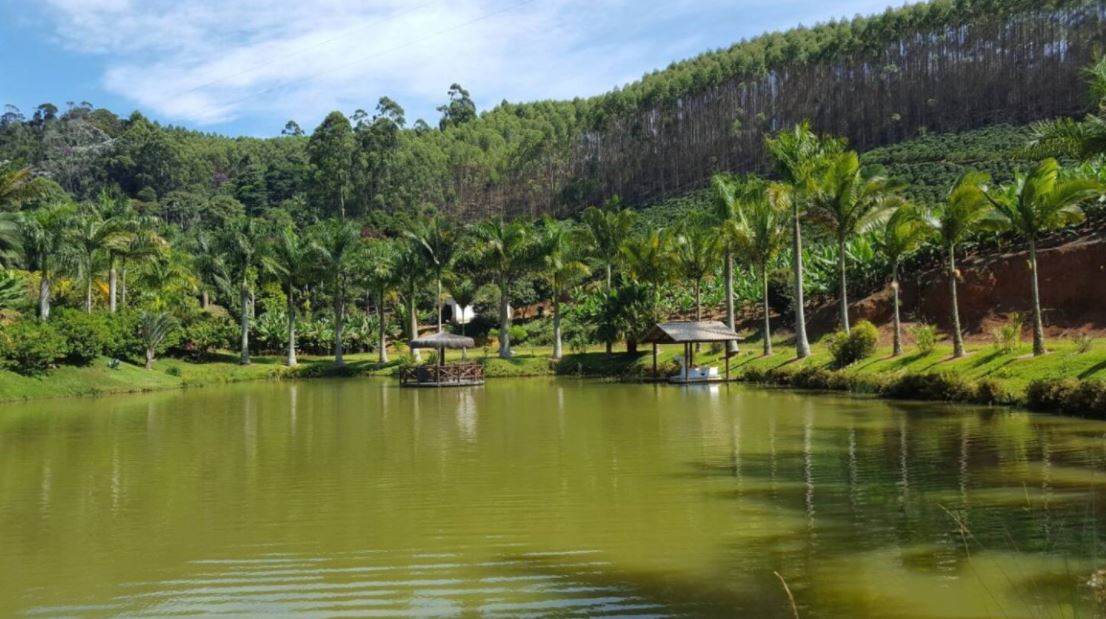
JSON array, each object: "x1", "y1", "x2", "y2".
[{"x1": 927, "y1": 171, "x2": 991, "y2": 357}]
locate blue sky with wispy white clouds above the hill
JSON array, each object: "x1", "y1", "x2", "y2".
[{"x1": 0, "y1": 0, "x2": 901, "y2": 136}]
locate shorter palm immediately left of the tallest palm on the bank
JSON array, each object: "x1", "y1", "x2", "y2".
[{"x1": 727, "y1": 183, "x2": 791, "y2": 356}]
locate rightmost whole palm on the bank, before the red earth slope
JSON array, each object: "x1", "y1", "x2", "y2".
[{"x1": 984, "y1": 159, "x2": 1106, "y2": 356}]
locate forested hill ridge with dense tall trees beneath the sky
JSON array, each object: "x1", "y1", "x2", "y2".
[{"x1": 0, "y1": 0, "x2": 1106, "y2": 222}]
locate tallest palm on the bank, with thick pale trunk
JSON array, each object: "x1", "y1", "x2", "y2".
[{"x1": 765, "y1": 123, "x2": 843, "y2": 359}]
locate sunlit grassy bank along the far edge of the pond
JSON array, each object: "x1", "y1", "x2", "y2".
[{"x1": 0, "y1": 343, "x2": 1106, "y2": 419}]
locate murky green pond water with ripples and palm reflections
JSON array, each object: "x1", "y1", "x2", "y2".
[{"x1": 0, "y1": 379, "x2": 1106, "y2": 619}]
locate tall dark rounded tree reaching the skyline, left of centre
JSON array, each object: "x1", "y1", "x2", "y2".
[{"x1": 307, "y1": 112, "x2": 354, "y2": 219}]
